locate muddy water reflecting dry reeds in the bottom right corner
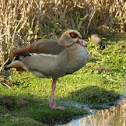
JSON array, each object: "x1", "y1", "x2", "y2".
[{"x1": 55, "y1": 99, "x2": 126, "y2": 126}]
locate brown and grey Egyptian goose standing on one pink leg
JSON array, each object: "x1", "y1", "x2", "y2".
[{"x1": 5, "y1": 30, "x2": 88, "y2": 109}]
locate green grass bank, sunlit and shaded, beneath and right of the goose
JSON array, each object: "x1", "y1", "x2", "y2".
[{"x1": 0, "y1": 36, "x2": 126, "y2": 126}]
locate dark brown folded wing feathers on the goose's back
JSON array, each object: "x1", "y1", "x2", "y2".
[{"x1": 12, "y1": 40, "x2": 64, "y2": 57}]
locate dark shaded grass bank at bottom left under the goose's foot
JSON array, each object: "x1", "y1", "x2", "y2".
[{"x1": 0, "y1": 88, "x2": 87, "y2": 126}]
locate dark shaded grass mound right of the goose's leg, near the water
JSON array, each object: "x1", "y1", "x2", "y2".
[{"x1": 67, "y1": 86, "x2": 120, "y2": 107}]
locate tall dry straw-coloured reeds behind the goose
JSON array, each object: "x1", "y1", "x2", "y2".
[{"x1": 0, "y1": 0, "x2": 126, "y2": 68}]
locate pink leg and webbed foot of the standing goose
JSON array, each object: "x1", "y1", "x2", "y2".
[{"x1": 49, "y1": 79, "x2": 65, "y2": 110}]
